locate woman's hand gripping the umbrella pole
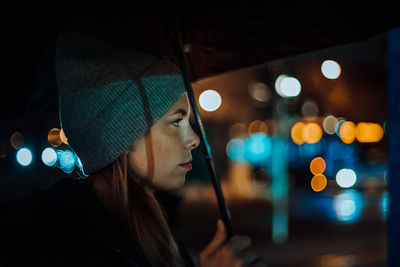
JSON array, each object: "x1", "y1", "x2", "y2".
[{"x1": 200, "y1": 219, "x2": 265, "y2": 267}]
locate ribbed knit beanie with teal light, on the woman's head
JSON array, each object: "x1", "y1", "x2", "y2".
[{"x1": 55, "y1": 31, "x2": 185, "y2": 175}]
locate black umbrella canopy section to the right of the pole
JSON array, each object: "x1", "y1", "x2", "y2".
[{"x1": 180, "y1": 1, "x2": 400, "y2": 80}]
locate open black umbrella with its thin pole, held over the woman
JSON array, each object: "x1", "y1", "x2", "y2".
[{"x1": 1, "y1": 1, "x2": 400, "y2": 241}]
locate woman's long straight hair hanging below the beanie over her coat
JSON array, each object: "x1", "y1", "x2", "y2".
[{"x1": 88, "y1": 153, "x2": 183, "y2": 267}]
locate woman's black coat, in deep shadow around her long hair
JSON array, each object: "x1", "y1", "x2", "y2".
[{"x1": 0, "y1": 178, "x2": 194, "y2": 267}]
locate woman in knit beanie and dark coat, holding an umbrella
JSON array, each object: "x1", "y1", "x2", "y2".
[{"x1": 0, "y1": 32, "x2": 260, "y2": 267}]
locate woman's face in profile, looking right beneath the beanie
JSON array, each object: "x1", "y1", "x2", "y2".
[{"x1": 128, "y1": 93, "x2": 200, "y2": 192}]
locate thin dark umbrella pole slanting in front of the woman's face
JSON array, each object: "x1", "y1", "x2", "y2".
[{"x1": 169, "y1": 17, "x2": 233, "y2": 239}]
